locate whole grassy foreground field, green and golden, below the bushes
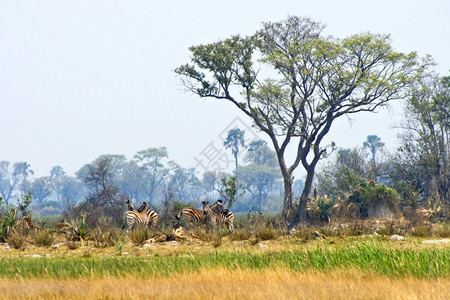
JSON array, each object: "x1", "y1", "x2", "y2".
[{"x1": 0, "y1": 232, "x2": 450, "y2": 299}]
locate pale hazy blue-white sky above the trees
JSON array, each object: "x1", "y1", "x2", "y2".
[{"x1": 0, "y1": 0, "x2": 450, "y2": 176}]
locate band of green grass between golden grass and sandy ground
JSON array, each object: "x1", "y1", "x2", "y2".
[{"x1": 0, "y1": 242, "x2": 450, "y2": 279}]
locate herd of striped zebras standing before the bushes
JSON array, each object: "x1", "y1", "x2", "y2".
[{"x1": 124, "y1": 200, "x2": 234, "y2": 232}]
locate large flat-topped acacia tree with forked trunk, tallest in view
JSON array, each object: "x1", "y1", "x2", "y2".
[{"x1": 175, "y1": 17, "x2": 426, "y2": 227}]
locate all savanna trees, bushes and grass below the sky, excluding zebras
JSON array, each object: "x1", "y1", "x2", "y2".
[{"x1": 0, "y1": 17, "x2": 450, "y2": 299}]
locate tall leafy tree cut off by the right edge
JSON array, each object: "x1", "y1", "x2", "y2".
[{"x1": 390, "y1": 75, "x2": 450, "y2": 213}]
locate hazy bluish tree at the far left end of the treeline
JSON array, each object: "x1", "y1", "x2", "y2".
[{"x1": 0, "y1": 161, "x2": 33, "y2": 205}]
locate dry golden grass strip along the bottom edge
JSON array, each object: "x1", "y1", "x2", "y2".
[{"x1": 0, "y1": 269, "x2": 450, "y2": 300}]
